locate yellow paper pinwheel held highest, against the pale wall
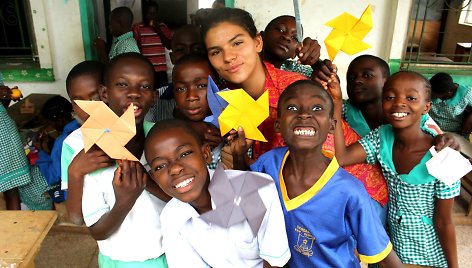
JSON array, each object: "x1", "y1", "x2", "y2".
[{"x1": 325, "y1": 5, "x2": 372, "y2": 61}]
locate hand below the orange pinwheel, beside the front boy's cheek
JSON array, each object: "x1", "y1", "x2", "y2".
[{"x1": 113, "y1": 160, "x2": 149, "y2": 209}]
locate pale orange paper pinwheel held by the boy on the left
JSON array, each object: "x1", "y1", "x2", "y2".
[{"x1": 75, "y1": 100, "x2": 139, "y2": 161}]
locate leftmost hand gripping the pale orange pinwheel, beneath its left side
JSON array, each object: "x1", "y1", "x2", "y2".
[{"x1": 69, "y1": 146, "x2": 113, "y2": 177}]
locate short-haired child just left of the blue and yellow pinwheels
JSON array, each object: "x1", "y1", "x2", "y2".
[{"x1": 172, "y1": 55, "x2": 223, "y2": 169}]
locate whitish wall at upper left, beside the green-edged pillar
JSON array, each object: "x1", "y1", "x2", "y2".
[{"x1": 13, "y1": 0, "x2": 85, "y2": 97}]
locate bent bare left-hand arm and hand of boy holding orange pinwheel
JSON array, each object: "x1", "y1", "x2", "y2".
[{"x1": 66, "y1": 147, "x2": 112, "y2": 225}]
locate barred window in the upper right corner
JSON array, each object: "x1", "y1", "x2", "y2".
[{"x1": 402, "y1": 0, "x2": 472, "y2": 69}]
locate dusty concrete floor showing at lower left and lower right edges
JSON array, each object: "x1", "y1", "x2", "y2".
[{"x1": 0, "y1": 192, "x2": 472, "y2": 268}]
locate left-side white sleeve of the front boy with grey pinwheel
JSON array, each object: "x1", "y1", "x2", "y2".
[{"x1": 161, "y1": 206, "x2": 210, "y2": 268}]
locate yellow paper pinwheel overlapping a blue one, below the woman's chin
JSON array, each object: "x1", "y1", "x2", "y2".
[{"x1": 218, "y1": 89, "x2": 269, "y2": 141}]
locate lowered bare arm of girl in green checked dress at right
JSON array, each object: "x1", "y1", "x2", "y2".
[{"x1": 434, "y1": 198, "x2": 459, "y2": 268}]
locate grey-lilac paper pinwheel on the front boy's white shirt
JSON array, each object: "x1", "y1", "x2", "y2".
[{"x1": 200, "y1": 165, "x2": 271, "y2": 236}]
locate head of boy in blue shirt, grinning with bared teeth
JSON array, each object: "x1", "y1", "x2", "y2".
[{"x1": 275, "y1": 80, "x2": 335, "y2": 151}]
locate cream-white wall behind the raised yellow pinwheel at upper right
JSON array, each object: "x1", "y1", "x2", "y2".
[{"x1": 234, "y1": 0, "x2": 412, "y2": 87}]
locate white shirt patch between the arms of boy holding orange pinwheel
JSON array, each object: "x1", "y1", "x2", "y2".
[{"x1": 82, "y1": 172, "x2": 111, "y2": 227}]
